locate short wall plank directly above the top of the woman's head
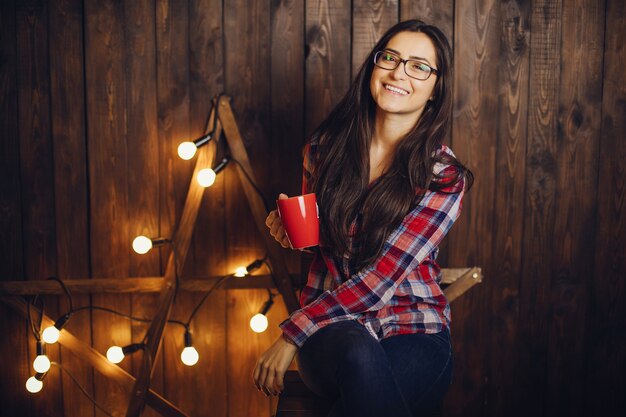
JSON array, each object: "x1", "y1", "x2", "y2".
[{"x1": 400, "y1": 0, "x2": 454, "y2": 41}]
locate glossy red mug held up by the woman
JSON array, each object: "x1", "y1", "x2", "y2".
[{"x1": 276, "y1": 193, "x2": 320, "y2": 249}]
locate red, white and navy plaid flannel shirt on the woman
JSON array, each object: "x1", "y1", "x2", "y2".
[{"x1": 280, "y1": 138, "x2": 464, "y2": 347}]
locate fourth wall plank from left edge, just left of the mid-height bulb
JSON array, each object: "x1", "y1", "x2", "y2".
[{"x1": 84, "y1": 1, "x2": 133, "y2": 417}]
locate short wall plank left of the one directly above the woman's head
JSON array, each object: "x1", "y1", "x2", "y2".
[{"x1": 351, "y1": 0, "x2": 398, "y2": 79}]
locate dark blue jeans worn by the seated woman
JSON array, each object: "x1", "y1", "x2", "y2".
[{"x1": 298, "y1": 320, "x2": 453, "y2": 417}]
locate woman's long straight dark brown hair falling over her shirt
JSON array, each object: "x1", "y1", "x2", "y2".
[{"x1": 309, "y1": 20, "x2": 473, "y2": 269}]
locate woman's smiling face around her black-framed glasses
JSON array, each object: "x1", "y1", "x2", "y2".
[{"x1": 370, "y1": 32, "x2": 437, "y2": 122}]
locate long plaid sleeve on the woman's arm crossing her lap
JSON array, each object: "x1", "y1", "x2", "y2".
[{"x1": 280, "y1": 167, "x2": 464, "y2": 346}]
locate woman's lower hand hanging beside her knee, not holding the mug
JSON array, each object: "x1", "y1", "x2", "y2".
[{"x1": 253, "y1": 336, "x2": 298, "y2": 395}]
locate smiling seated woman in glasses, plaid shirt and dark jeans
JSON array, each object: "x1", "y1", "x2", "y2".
[{"x1": 253, "y1": 20, "x2": 473, "y2": 417}]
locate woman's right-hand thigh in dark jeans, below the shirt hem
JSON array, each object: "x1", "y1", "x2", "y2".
[{"x1": 381, "y1": 329, "x2": 453, "y2": 416}]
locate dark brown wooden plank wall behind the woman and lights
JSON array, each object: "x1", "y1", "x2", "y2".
[{"x1": 0, "y1": 0, "x2": 626, "y2": 417}]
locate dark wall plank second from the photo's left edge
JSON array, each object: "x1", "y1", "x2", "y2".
[{"x1": 16, "y1": 4, "x2": 63, "y2": 416}]
